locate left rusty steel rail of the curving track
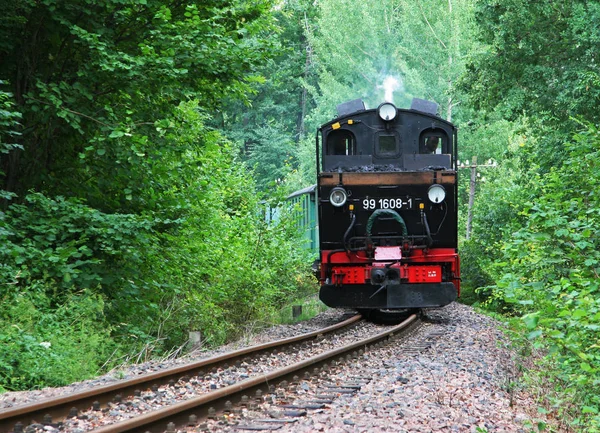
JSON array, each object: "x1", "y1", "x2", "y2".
[{"x1": 0, "y1": 314, "x2": 362, "y2": 432}]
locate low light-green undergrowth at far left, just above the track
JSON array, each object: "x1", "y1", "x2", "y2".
[{"x1": 0, "y1": 283, "x2": 117, "y2": 391}]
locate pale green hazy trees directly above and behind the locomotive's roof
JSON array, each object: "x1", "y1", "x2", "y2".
[{"x1": 311, "y1": 0, "x2": 473, "y2": 124}]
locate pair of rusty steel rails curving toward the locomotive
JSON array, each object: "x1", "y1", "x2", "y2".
[{"x1": 0, "y1": 315, "x2": 416, "y2": 433}]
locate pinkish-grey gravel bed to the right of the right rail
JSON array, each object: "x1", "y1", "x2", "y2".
[{"x1": 278, "y1": 303, "x2": 560, "y2": 432}]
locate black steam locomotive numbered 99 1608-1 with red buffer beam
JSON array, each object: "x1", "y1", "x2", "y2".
[{"x1": 316, "y1": 99, "x2": 460, "y2": 310}]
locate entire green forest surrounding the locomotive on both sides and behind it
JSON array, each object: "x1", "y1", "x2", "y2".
[{"x1": 0, "y1": 0, "x2": 600, "y2": 431}]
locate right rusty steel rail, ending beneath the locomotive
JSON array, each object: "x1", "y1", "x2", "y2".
[{"x1": 93, "y1": 314, "x2": 417, "y2": 433}]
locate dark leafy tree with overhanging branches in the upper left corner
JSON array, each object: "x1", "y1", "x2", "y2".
[{"x1": 0, "y1": 0, "x2": 273, "y2": 210}]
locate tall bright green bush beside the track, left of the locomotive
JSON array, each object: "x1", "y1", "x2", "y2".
[{"x1": 125, "y1": 102, "x2": 314, "y2": 345}]
